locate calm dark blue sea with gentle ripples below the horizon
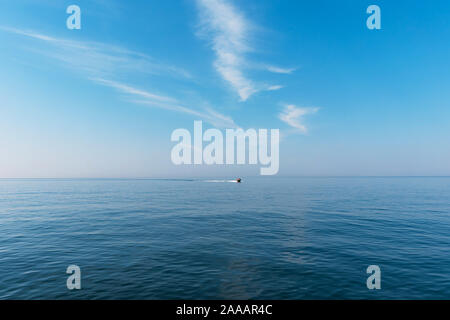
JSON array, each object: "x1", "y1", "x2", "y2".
[{"x1": 0, "y1": 177, "x2": 450, "y2": 299}]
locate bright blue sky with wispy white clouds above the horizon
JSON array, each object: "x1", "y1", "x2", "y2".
[{"x1": 0, "y1": 0, "x2": 450, "y2": 178}]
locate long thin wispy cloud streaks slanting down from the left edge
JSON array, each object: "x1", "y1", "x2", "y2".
[{"x1": 0, "y1": 27, "x2": 237, "y2": 128}]
